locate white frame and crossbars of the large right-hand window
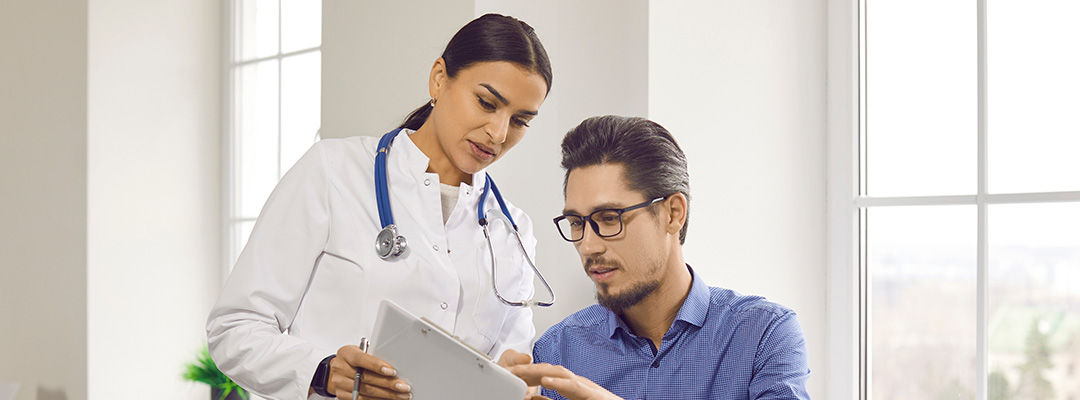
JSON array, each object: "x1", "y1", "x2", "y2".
[{"x1": 826, "y1": 0, "x2": 1080, "y2": 400}]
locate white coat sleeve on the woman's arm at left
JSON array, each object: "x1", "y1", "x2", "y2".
[{"x1": 206, "y1": 143, "x2": 329, "y2": 399}]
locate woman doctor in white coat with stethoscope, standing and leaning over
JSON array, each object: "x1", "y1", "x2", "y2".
[{"x1": 206, "y1": 14, "x2": 552, "y2": 399}]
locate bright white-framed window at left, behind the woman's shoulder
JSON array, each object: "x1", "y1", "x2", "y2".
[{"x1": 225, "y1": 0, "x2": 322, "y2": 270}]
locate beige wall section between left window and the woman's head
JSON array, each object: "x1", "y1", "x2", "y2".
[{"x1": 320, "y1": 0, "x2": 472, "y2": 137}]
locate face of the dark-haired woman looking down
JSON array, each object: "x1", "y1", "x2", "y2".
[{"x1": 429, "y1": 58, "x2": 548, "y2": 174}]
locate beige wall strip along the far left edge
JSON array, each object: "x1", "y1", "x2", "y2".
[{"x1": 0, "y1": 1, "x2": 86, "y2": 400}]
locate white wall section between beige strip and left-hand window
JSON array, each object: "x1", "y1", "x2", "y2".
[{"x1": 85, "y1": 0, "x2": 225, "y2": 400}]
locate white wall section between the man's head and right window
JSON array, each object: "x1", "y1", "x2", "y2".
[{"x1": 648, "y1": 0, "x2": 828, "y2": 398}]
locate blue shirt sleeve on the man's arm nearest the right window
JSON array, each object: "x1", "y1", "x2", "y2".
[{"x1": 748, "y1": 310, "x2": 810, "y2": 400}]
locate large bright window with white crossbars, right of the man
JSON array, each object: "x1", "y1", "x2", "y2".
[{"x1": 851, "y1": 0, "x2": 1080, "y2": 400}]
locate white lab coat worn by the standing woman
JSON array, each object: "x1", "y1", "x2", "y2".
[{"x1": 206, "y1": 132, "x2": 536, "y2": 399}]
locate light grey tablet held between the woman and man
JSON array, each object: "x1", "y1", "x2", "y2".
[{"x1": 369, "y1": 299, "x2": 526, "y2": 400}]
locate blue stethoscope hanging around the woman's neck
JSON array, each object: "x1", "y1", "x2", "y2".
[{"x1": 375, "y1": 129, "x2": 555, "y2": 307}]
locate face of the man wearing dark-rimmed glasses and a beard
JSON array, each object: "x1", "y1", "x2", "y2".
[{"x1": 563, "y1": 164, "x2": 667, "y2": 312}]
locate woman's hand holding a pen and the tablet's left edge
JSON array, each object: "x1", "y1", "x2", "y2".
[{"x1": 326, "y1": 345, "x2": 413, "y2": 400}]
